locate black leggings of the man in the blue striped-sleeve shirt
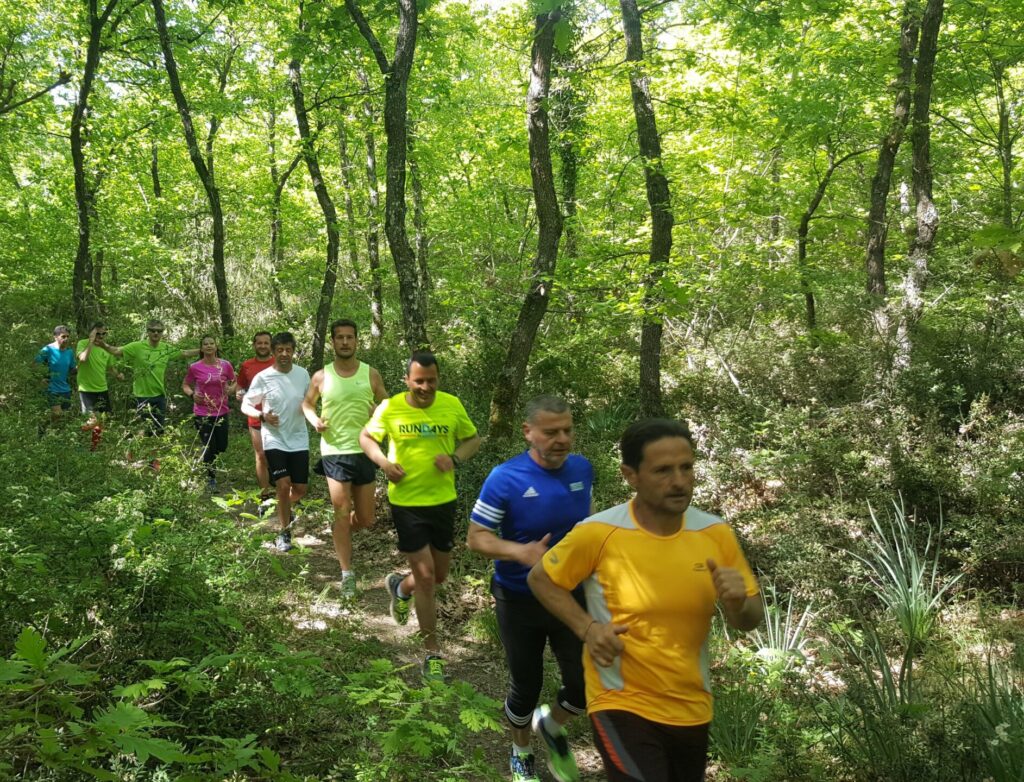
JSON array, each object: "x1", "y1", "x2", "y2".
[{"x1": 493, "y1": 584, "x2": 587, "y2": 728}]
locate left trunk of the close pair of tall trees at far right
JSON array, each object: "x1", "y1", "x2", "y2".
[{"x1": 865, "y1": 0, "x2": 919, "y2": 302}]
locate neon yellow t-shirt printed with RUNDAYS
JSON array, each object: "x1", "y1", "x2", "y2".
[{"x1": 367, "y1": 391, "x2": 476, "y2": 507}]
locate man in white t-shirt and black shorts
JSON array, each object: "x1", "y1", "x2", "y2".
[{"x1": 242, "y1": 332, "x2": 309, "y2": 552}]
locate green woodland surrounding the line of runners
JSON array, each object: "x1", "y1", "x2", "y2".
[{"x1": 0, "y1": 0, "x2": 1024, "y2": 782}]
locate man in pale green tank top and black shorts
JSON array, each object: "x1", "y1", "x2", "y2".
[{"x1": 302, "y1": 319, "x2": 387, "y2": 599}]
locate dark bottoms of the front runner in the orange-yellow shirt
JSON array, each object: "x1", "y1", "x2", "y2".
[{"x1": 590, "y1": 709, "x2": 708, "y2": 782}]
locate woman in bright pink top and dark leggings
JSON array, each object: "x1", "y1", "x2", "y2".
[{"x1": 181, "y1": 335, "x2": 234, "y2": 491}]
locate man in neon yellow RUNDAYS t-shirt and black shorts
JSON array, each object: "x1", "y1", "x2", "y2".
[{"x1": 359, "y1": 351, "x2": 480, "y2": 681}]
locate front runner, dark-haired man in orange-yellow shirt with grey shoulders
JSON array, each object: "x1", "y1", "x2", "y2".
[{"x1": 527, "y1": 419, "x2": 763, "y2": 782}]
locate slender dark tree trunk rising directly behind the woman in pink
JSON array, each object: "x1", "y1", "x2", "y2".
[{"x1": 153, "y1": 0, "x2": 234, "y2": 337}]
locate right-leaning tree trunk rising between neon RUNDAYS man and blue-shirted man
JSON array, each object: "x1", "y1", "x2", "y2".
[{"x1": 490, "y1": 8, "x2": 562, "y2": 437}]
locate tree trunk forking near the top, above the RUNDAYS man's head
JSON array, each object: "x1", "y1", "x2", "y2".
[{"x1": 345, "y1": 0, "x2": 429, "y2": 349}]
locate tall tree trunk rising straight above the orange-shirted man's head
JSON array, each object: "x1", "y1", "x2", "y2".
[{"x1": 618, "y1": 0, "x2": 674, "y2": 418}]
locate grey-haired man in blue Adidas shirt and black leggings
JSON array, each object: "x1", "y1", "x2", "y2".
[{"x1": 466, "y1": 396, "x2": 594, "y2": 782}]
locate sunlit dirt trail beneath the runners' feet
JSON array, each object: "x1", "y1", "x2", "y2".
[{"x1": 232, "y1": 492, "x2": 605, "y2": 782}]
